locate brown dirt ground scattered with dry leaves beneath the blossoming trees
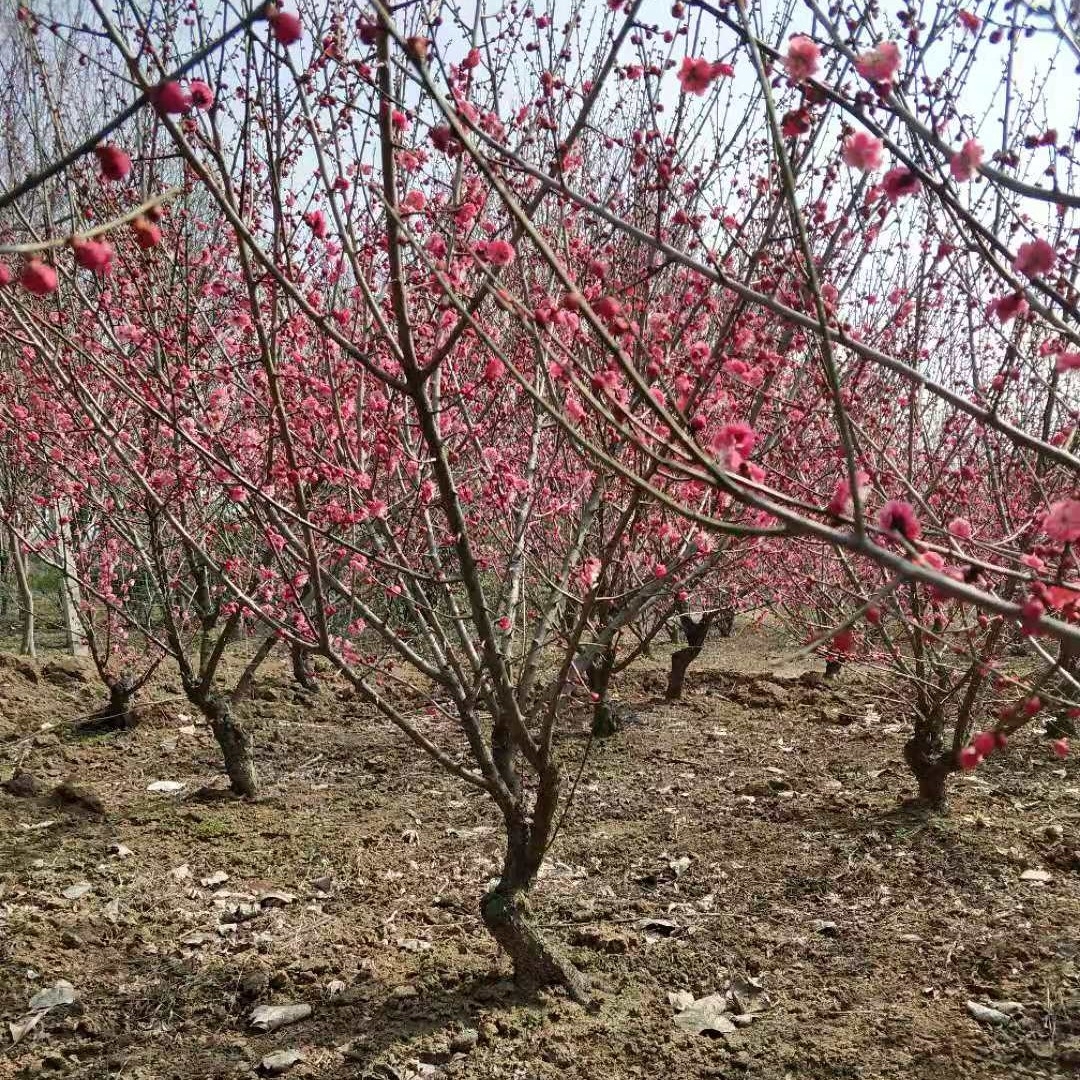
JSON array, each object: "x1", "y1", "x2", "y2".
[{"x1": 0, "y1": 633, "x2": 1080, "y2": 1080}]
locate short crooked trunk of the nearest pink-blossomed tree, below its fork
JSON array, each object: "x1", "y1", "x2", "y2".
[{"x1": 480, "y1": 826, "x2": 589, "y2": 1004}]
